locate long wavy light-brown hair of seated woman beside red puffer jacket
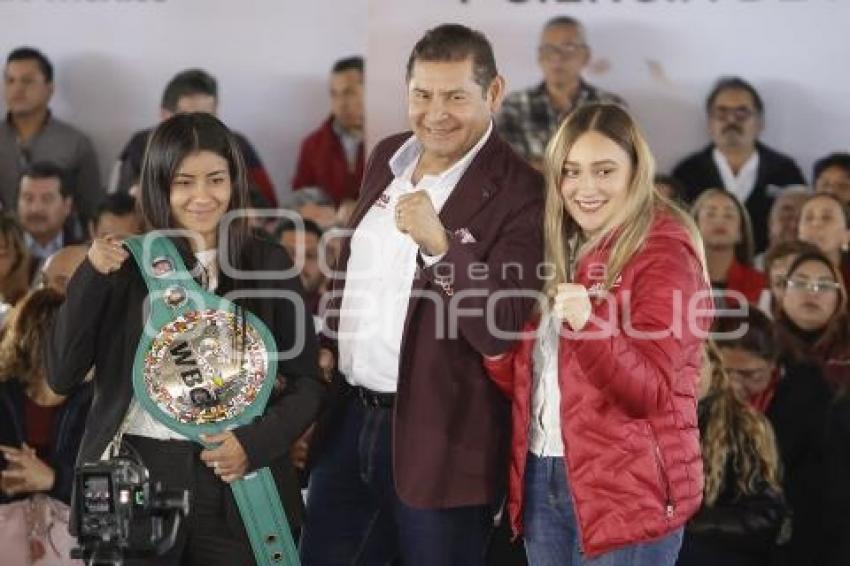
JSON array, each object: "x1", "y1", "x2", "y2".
[{"x1": 700, "y1": 341, "x2": 782, "y2": 507}]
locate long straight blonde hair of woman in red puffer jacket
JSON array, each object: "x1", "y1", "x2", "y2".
[{"x1": 543, "y1": 104, "x2": 708, "y2": 297}]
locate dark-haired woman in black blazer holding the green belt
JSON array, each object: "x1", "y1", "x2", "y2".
[{"x1": 48, "y1": 114, "x2": 324, "y2": 566}]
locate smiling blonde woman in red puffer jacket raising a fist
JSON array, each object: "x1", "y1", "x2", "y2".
[{"x1": 486, "y1": 104, "x2": 712, "y2": 566}]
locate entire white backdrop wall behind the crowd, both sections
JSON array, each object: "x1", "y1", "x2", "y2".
[{"x1": 0, "y1": 0, "x2": 850, "y2": 200}]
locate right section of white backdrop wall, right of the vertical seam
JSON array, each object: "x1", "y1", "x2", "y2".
[{"x1": 367, "y1": 0, "x2": 850, "y2": 178}]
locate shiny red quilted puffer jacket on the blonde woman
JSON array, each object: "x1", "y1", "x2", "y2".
[{"x1": 486, "y1": 213, "x2": 713, "y2": 557}]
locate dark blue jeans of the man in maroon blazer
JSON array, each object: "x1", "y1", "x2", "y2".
[{"x1": 301, "y1": 398, "x2": 493, "y2": 566}]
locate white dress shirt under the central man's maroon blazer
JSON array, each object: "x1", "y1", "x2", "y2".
[{"x1": 337, "y1": 123, "x2": 493, "y2": 393}]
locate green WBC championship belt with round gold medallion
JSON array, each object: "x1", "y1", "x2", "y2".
[{"x1": 124, "y1": 232, "x2": 299, "y2": 566}]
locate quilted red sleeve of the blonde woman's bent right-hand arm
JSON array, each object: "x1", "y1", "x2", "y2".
[{"x1": 563, "y1": 238, "x2": 711, "y2": 418}]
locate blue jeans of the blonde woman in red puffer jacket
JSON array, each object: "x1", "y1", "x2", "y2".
[{"x1": 523, "y1": 453, "x2": 682, "y2": 566}]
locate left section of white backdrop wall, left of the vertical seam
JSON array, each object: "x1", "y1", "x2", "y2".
[{"x1": 0, "y1": 0, "x2": 367, "y2": 202}]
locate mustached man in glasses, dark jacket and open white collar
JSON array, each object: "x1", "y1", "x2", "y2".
[{"x1": 673, "y1": 77, "x2": 805, "y2": 252}]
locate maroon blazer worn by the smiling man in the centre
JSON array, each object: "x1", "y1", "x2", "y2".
[{"x1": 316, "y1": 130, "x2": 543, "y2": 508}]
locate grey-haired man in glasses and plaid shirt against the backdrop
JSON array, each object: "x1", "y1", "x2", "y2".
[{"x1": 496, "y1": 16, "x2": 622, "y2": 170}]
